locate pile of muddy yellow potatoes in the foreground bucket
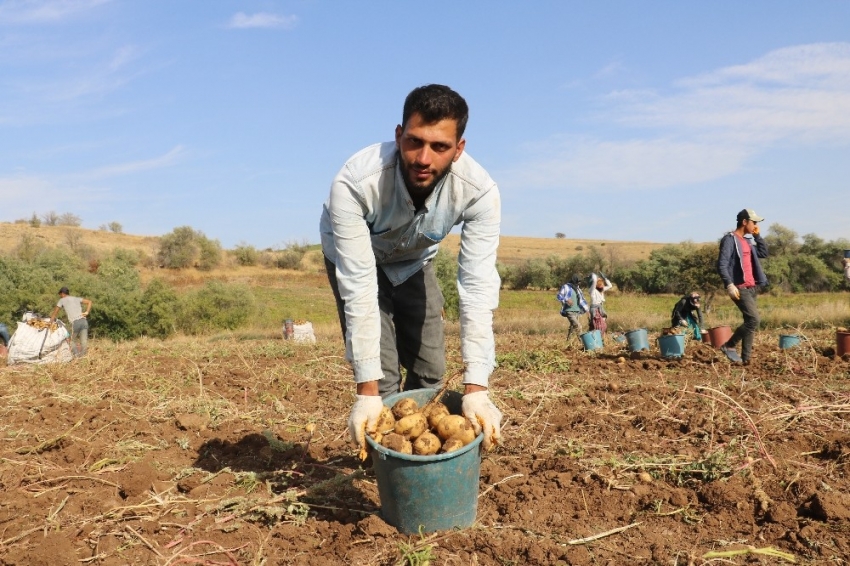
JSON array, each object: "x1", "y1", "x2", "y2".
[{"x1": 371, "y1": 397, "x2": 475, "y2": 456}]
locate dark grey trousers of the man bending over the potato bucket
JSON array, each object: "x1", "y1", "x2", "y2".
[{"x1": 325, "y1": 258, "x2": 446, "y2": 397}]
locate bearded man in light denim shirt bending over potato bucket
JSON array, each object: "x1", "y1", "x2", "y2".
[{"x1": 319, "y1": 84, "x2": 502, "y2": 455}]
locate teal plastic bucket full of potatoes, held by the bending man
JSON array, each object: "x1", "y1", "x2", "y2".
[{"x1": 366, "y1": 389, "x2": 484, "y2": 534}]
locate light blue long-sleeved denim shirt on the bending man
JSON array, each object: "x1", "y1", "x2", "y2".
[{"x1": 319, "y1": 142, "x2": 501, "y2": 387}]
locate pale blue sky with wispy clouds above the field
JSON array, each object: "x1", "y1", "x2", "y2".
[{"x1": 0, "y1": 0, "x2": 850, "y2": 248}]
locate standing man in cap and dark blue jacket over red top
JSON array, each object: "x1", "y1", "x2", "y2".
[{"x1": 717, "y1": 208, "x2": 768, "y2": 365}]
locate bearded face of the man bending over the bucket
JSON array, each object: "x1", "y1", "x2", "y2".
[{"x1": 395, "y1": 114, "x2": 466, "y2": 197}]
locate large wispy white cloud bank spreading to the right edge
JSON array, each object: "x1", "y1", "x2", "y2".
[{"x1": 503, "y1": 43, "x2": 850, "y2": 190}]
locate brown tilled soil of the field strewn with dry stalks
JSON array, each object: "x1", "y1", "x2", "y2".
[{"x1": 0, "y1": 332, "x2": 850, "y2": 566}]
